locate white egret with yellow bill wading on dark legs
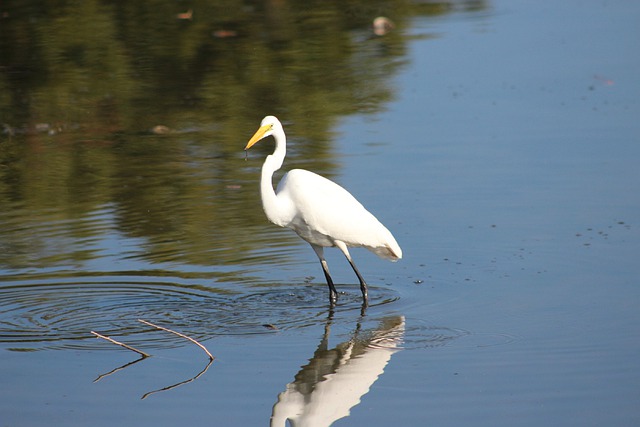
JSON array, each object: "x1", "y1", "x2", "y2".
[{"x1": 245, "y1": 116, "x2": 402, "y2": 305}]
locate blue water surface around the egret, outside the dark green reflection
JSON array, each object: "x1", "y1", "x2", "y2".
[{"x1": 0, "y1": 1, "x2": 640, "y2": 426}]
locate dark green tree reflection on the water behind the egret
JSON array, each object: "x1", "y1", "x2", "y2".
[{"x1": 0, "y1": 0, "x2": 482, "y2": 269}]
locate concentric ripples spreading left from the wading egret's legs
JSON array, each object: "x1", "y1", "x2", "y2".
[{"x1": 0, "y1": 277, "x2": 397, "y2": 351}]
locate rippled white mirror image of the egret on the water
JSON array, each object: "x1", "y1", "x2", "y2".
[{"x1": 271, "y1": 314, "x2": 405, "y2": 427}]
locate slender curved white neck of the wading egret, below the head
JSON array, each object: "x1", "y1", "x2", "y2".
[{"x1": 260, "y1": 132, "x2": 288, "y2": 226}]
